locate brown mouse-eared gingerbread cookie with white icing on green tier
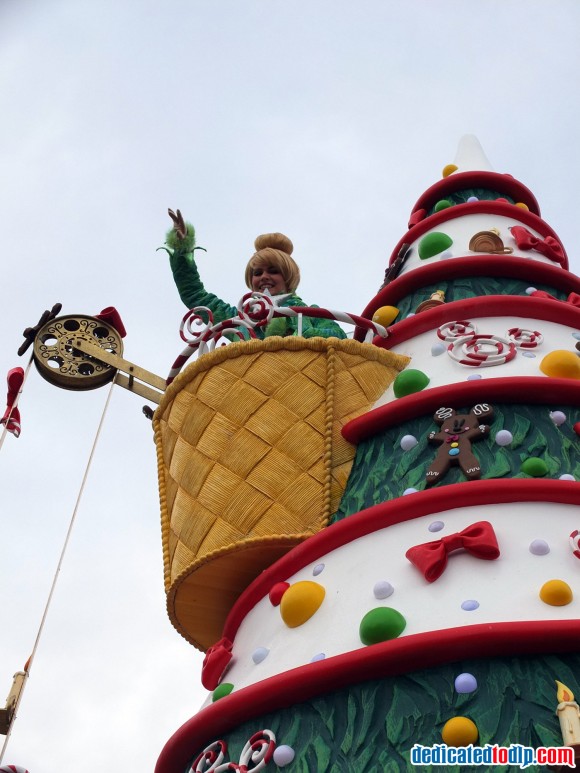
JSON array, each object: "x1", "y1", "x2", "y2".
[{"x1": 427, "y1": 403, "x2": 493, "y2": 486}]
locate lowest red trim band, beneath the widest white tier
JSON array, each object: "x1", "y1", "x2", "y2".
[{"x1": 155, "y1": 616, "x2": 580, "y2": 773}]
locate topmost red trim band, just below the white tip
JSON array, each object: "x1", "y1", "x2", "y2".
[{"x1": 411, "y1": 171, "x2": 540, "y2": 217}]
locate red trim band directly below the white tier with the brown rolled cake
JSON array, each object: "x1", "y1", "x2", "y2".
[{"x1": 357, "y1": 255, "x2": 580, "y2": 341}]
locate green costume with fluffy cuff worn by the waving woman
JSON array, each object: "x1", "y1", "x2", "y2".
[{"x1": 166, "y1": 223, "x2": 346, "y2": 338}]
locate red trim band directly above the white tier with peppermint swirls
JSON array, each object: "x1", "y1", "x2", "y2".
[{"x1": 374, "y1": 295, "x2": 580, "y2": 349}]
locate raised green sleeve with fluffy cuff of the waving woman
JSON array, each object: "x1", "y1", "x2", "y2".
[{"x1": 165, "y1": 223, "x2": 237, "y2": 322}]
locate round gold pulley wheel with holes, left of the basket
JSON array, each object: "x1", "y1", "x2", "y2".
[{"x1": 34, "y1": 314, "x2": 123, "y2": 390}]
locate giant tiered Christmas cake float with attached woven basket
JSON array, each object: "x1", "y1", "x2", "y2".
[{"x1": 154, "y1": 137, "x2": 580, "y2": 773}]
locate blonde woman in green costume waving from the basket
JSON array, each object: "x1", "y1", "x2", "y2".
[{"x1": 166, "y1": 209, "x2": 346, "y2": 338}]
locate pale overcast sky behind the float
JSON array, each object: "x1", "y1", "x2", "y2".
[{"x1": 0, "y1": 0, "x2": 580, "y2": 773}]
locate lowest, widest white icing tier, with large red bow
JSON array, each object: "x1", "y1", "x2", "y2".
[{"x1": 223, "y1": 500, "x2": 580, "y2": 690}]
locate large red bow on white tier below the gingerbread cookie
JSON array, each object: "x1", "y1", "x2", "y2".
[{"x1": 405, "y1": 521, "x2": 499, "y2": 582}]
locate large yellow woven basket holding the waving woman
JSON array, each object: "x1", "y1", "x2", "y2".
[{"x1": 153, "y1": 337, "x2": 408, "y2": 649}]
